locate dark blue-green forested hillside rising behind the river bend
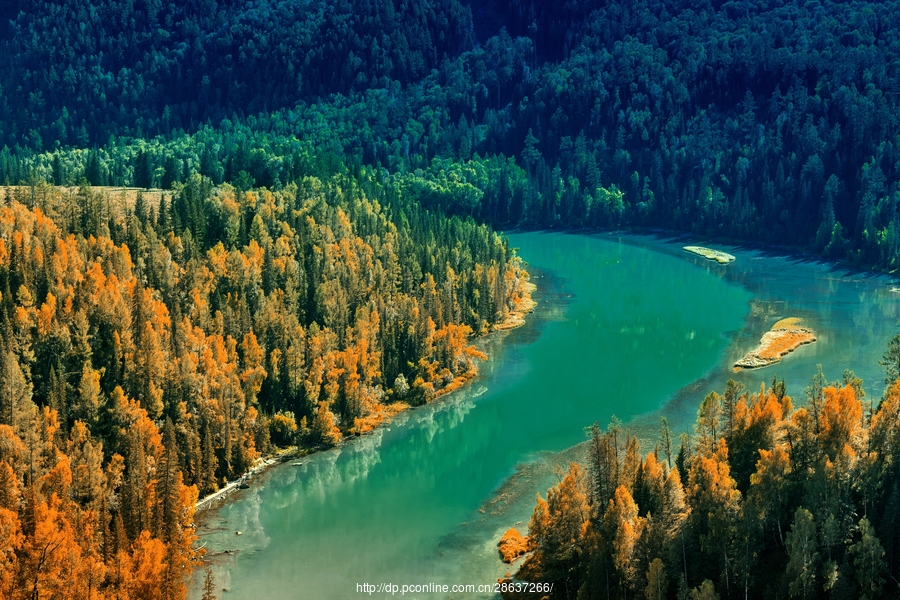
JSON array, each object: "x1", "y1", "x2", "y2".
[{"x1": 0, "y1": 0, "x2": 900, "y2": 269}]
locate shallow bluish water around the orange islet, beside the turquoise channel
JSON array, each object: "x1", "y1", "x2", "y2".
[{"x1": 622, "y1": 235, "x2": 900, "y2": 433}]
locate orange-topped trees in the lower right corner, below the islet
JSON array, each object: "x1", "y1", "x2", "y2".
[{"x1": 504, "y1": 360, "x2": 900, "y2": 600}]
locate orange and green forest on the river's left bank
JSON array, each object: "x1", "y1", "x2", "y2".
[{"x1": 0, "y1": 163, "x2": 527, "y2": 599}]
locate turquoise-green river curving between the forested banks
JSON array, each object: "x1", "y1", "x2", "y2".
[{"x1": 191, "y1": 233, "x2": 900, "y2": 600}]
